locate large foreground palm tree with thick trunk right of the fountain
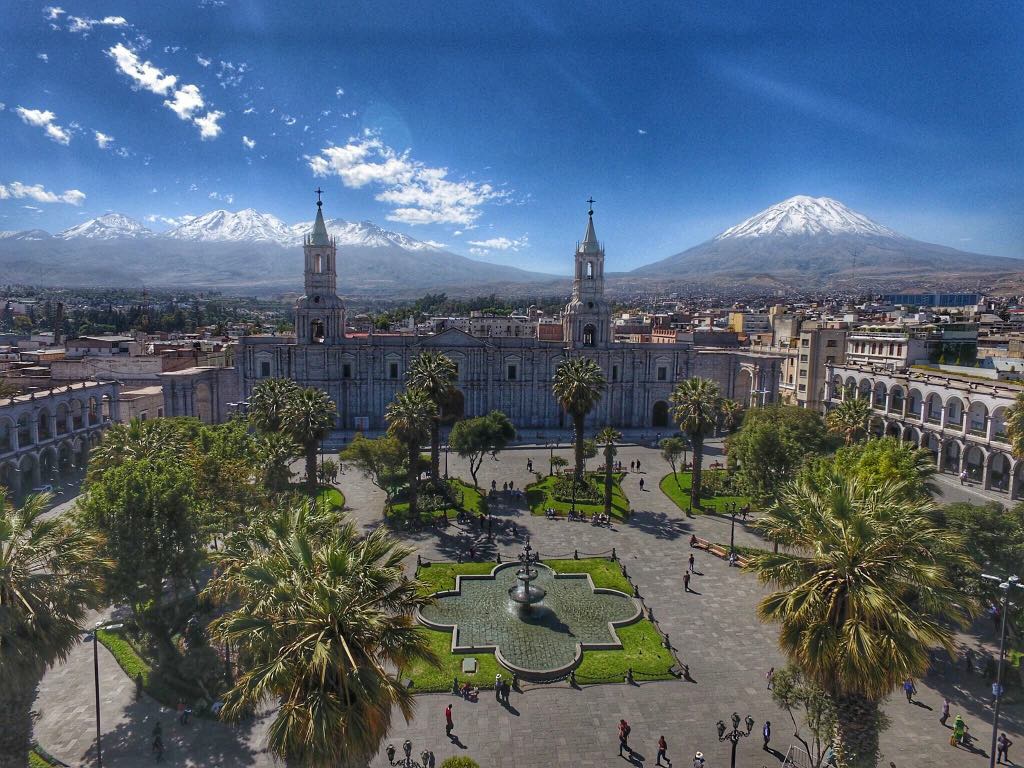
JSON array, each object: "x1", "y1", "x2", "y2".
[{"x1": 750, "y1": 475, "x2": 973, "y2": 768}]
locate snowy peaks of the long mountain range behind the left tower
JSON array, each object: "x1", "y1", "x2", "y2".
[{"x1": 0, "y1": 208, "x2": 441, "y2": 252}]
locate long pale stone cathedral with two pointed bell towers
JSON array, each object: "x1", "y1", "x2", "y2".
[{"x1": 236, "y1": 201, "x2": 779, "y2": 431}]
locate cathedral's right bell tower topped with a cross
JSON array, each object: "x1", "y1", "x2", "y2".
[{"x1": 562, "y1": 198, "x2": 611, "y2": 347}]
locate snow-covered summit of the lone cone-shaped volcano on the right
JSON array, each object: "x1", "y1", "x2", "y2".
[{"x1": 715, "y1": 195, "x2": 902, "y2": 241}]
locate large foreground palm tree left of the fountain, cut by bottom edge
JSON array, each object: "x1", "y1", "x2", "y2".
[{"x1": 208, "y1": 506, "x2": 437, "y2": 768}]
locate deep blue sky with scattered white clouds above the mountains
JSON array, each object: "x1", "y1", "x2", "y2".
[{"x1": 0, "y1": 0, "x2": 1024, "y2": 271}]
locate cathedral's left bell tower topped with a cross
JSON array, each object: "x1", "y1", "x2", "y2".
[{"x1": 295, "y1": 188, "x2": 345, "y2": 344}]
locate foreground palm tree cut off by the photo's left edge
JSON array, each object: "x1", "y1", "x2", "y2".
[{"x1": 0, "y1": 490, "x2": 108, "y2": 765}]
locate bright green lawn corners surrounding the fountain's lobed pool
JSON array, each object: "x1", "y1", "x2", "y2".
[{"x1": 401, "y1": 557, "x2": 675, "y2": 692}]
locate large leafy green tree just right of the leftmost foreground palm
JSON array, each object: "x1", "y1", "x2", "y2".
[{"x1": 78, "y1": 457, "x2": 203, "y2": 663}]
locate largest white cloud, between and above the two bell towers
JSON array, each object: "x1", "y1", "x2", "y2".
[{"x1": 306, "y1": 132, "x2": 508, "y2": 227}]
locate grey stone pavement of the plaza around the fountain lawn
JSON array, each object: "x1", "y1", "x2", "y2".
[{"x1": 29, "y1": 443, "x2": 1024, "y2": 768}]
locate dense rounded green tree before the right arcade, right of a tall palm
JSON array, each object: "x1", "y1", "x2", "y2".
[{"x1": 726, "y1": 406, "x2": 833, "y2": 503}]
